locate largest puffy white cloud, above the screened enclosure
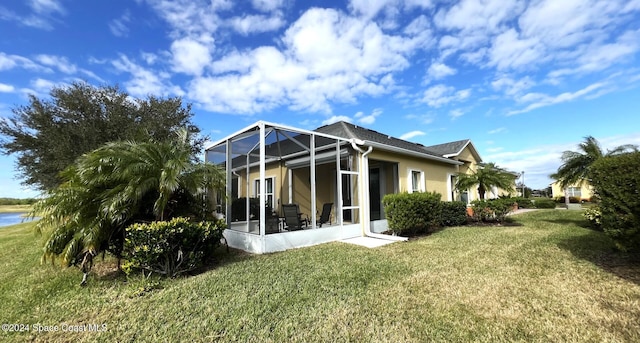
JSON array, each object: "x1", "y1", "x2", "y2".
[{"x1": 189, "y1": 8, "x2": 424, "y2": 114}]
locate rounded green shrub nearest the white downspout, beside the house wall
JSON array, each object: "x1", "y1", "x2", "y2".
[{"x1": 382, "y1": 192, "x2": 442, "y2": 234}]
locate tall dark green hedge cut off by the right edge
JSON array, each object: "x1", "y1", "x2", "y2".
[{"x1": 591, "y1": 152, "x2": 640, "y2": 251}]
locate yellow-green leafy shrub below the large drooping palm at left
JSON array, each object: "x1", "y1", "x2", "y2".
[{"x1": 123, "y1": 218, "x2": 226, "y2": 277}]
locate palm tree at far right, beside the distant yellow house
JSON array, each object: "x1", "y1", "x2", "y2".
[{"x1": 551, "y1": 136, "x2": 638, "y2": 191}]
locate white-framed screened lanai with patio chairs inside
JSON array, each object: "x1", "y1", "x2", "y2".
[{"x1": 205, "y1": 121, "x2": 366, "y2": 253}]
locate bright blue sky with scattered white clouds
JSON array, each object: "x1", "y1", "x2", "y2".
[{"x1": 0, "y1": 0, "x2": 640, "y2": 197}]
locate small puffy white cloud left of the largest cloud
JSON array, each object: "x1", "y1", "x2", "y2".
[{"x1": 171, "y1": 38, "x2": 212, "y2": 75}]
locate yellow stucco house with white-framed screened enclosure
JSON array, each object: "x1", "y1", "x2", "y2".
[{"x1": 205, "y1": 121, "x2": 490, "y2": 253}]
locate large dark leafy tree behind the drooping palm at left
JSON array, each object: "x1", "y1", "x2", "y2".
[{"x1": 0, "y1": 82, "x2": 204, "y2": 190}]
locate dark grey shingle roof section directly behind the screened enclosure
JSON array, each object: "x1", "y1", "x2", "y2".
[{"x1": 314, "y1": 121, "x2": 442, "y2": 157}]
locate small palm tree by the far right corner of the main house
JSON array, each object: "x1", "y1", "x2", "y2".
[{"x1": 456, "y1": 163, "x2": 515, "y2": 200}]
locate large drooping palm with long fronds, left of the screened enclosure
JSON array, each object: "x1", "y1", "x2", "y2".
[{"x1": 32, "y1": 130, "x2": 225, "y2": 275}]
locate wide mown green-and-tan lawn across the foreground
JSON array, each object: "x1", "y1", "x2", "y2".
[{"x1": 0, "y1": 210, "x2": 640, "y2": 342}]
